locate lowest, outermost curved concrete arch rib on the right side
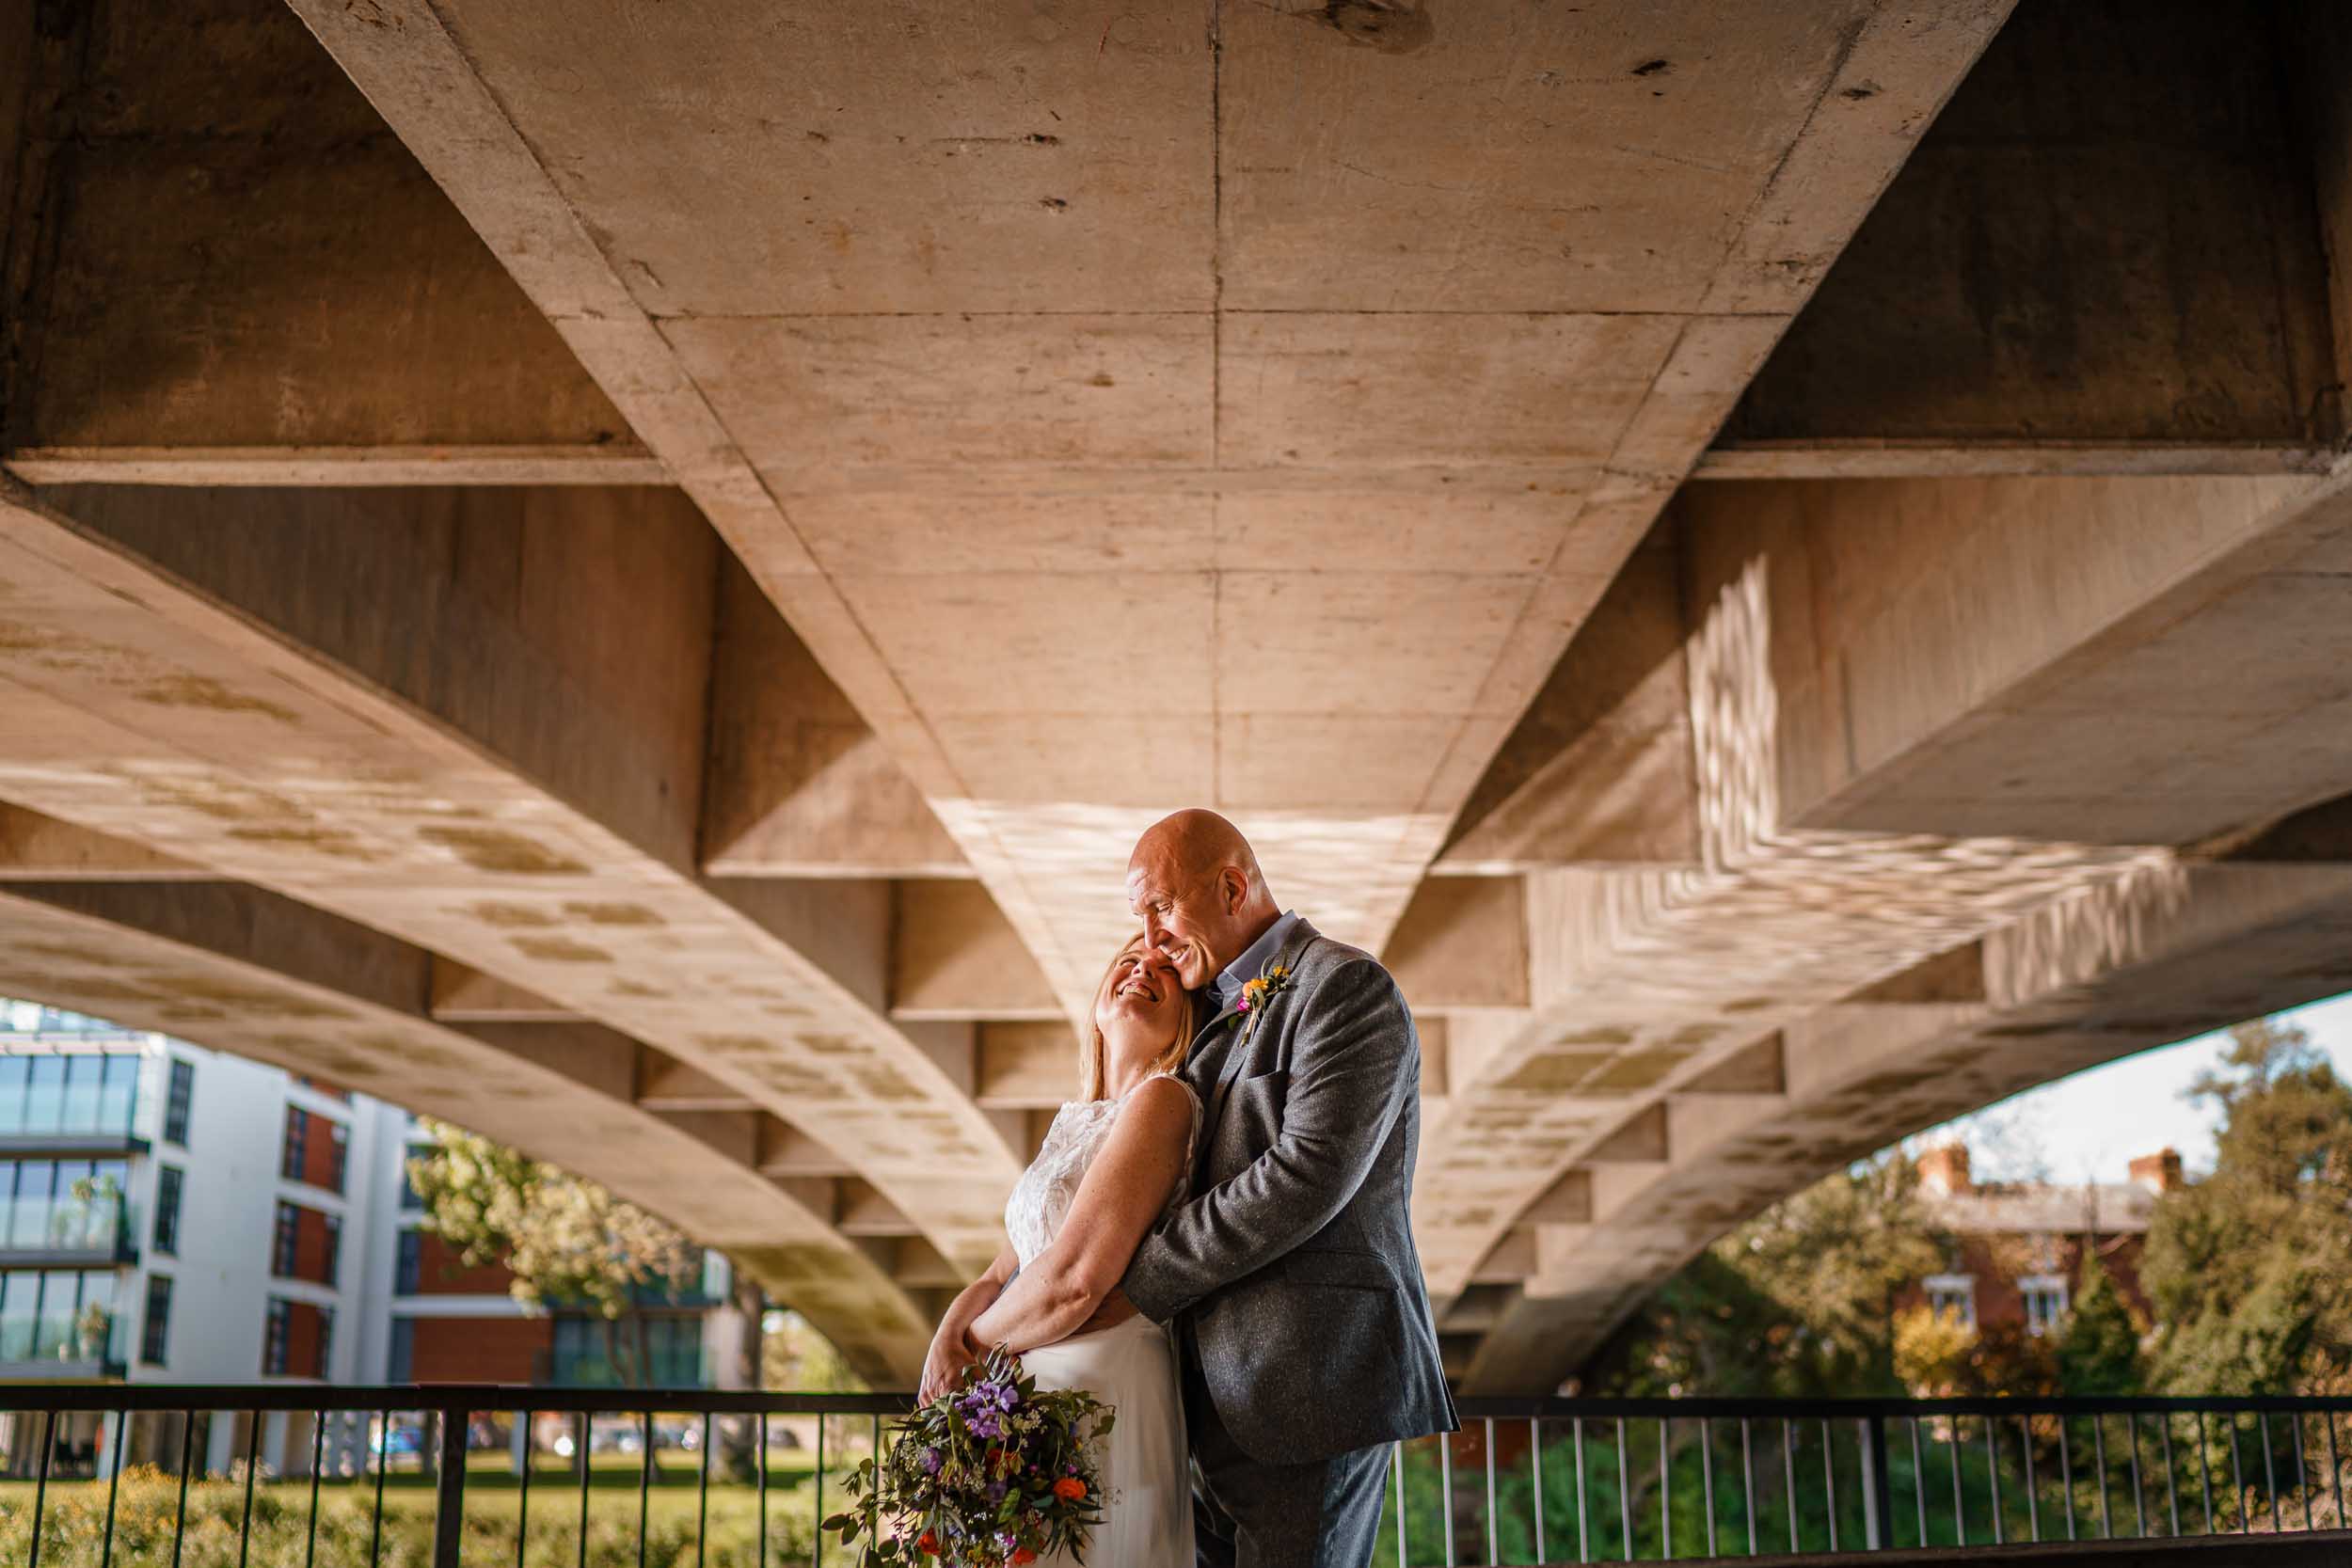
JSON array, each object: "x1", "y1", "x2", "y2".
[{"x1": 1466, "y1": 856, "x2": 2352, "y2": 1392}]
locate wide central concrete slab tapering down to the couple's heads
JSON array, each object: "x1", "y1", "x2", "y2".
[{"x1": 270, "y1": 0, "x2": 2009, "y2": 1011}]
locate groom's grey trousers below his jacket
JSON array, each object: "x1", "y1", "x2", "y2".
[{"x1": 1185, "y1": 1380, "x2": 1388, "y2": 1568}]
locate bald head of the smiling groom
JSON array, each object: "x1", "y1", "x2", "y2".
[{"x1": 1127, "y1": 811, "x2": 1282, "y2": 990}]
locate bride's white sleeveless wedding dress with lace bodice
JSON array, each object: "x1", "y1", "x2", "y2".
[{"x1": 1005, "y1": 1074, "x2": 1200, "y2": 1568}]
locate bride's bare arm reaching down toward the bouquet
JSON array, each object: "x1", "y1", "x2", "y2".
[{"x1": 972, "y1": 1079, "x2": 1193, "y2": 1350}]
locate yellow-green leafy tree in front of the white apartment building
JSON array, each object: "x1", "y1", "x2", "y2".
[{"x1": 409, "y1": 1121, "x2": 701, "y2": 1385}]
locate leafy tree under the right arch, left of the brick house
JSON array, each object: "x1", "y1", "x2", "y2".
[{"x1": 1585, "y1": 1149, "x2": 1947, "y2": 1397}]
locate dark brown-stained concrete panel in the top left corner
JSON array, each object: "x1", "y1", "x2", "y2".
[{"x1": 0, "y1": 0, "x2": 644, "y2": 484}]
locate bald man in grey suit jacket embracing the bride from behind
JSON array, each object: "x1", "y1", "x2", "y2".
[{"x1": 1120, "y1": 811, "x2": 1458, "y2": 1568}]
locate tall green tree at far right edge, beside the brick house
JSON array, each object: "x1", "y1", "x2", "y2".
[{"x1": 2140, "y1": 1021, "x2": 2352, "y2": 1394}]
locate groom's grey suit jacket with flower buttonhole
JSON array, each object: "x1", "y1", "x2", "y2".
[{"x1": 1120, "y1": 919, "x2": 1458, "y2": 1465}]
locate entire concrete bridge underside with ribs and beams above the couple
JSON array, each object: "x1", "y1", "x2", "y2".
[{"x1": 0, "y1": 0, "x2": 2352, "y2": 1392}]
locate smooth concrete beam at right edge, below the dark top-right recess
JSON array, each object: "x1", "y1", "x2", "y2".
[{"x1": 1682, "y1": 475, "x2": 2352, "y2": 844}]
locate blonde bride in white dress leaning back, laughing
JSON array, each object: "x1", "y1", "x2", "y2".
[{"x1": 922, "y1": 936, "x2": 1200, "y2": 1568}]
